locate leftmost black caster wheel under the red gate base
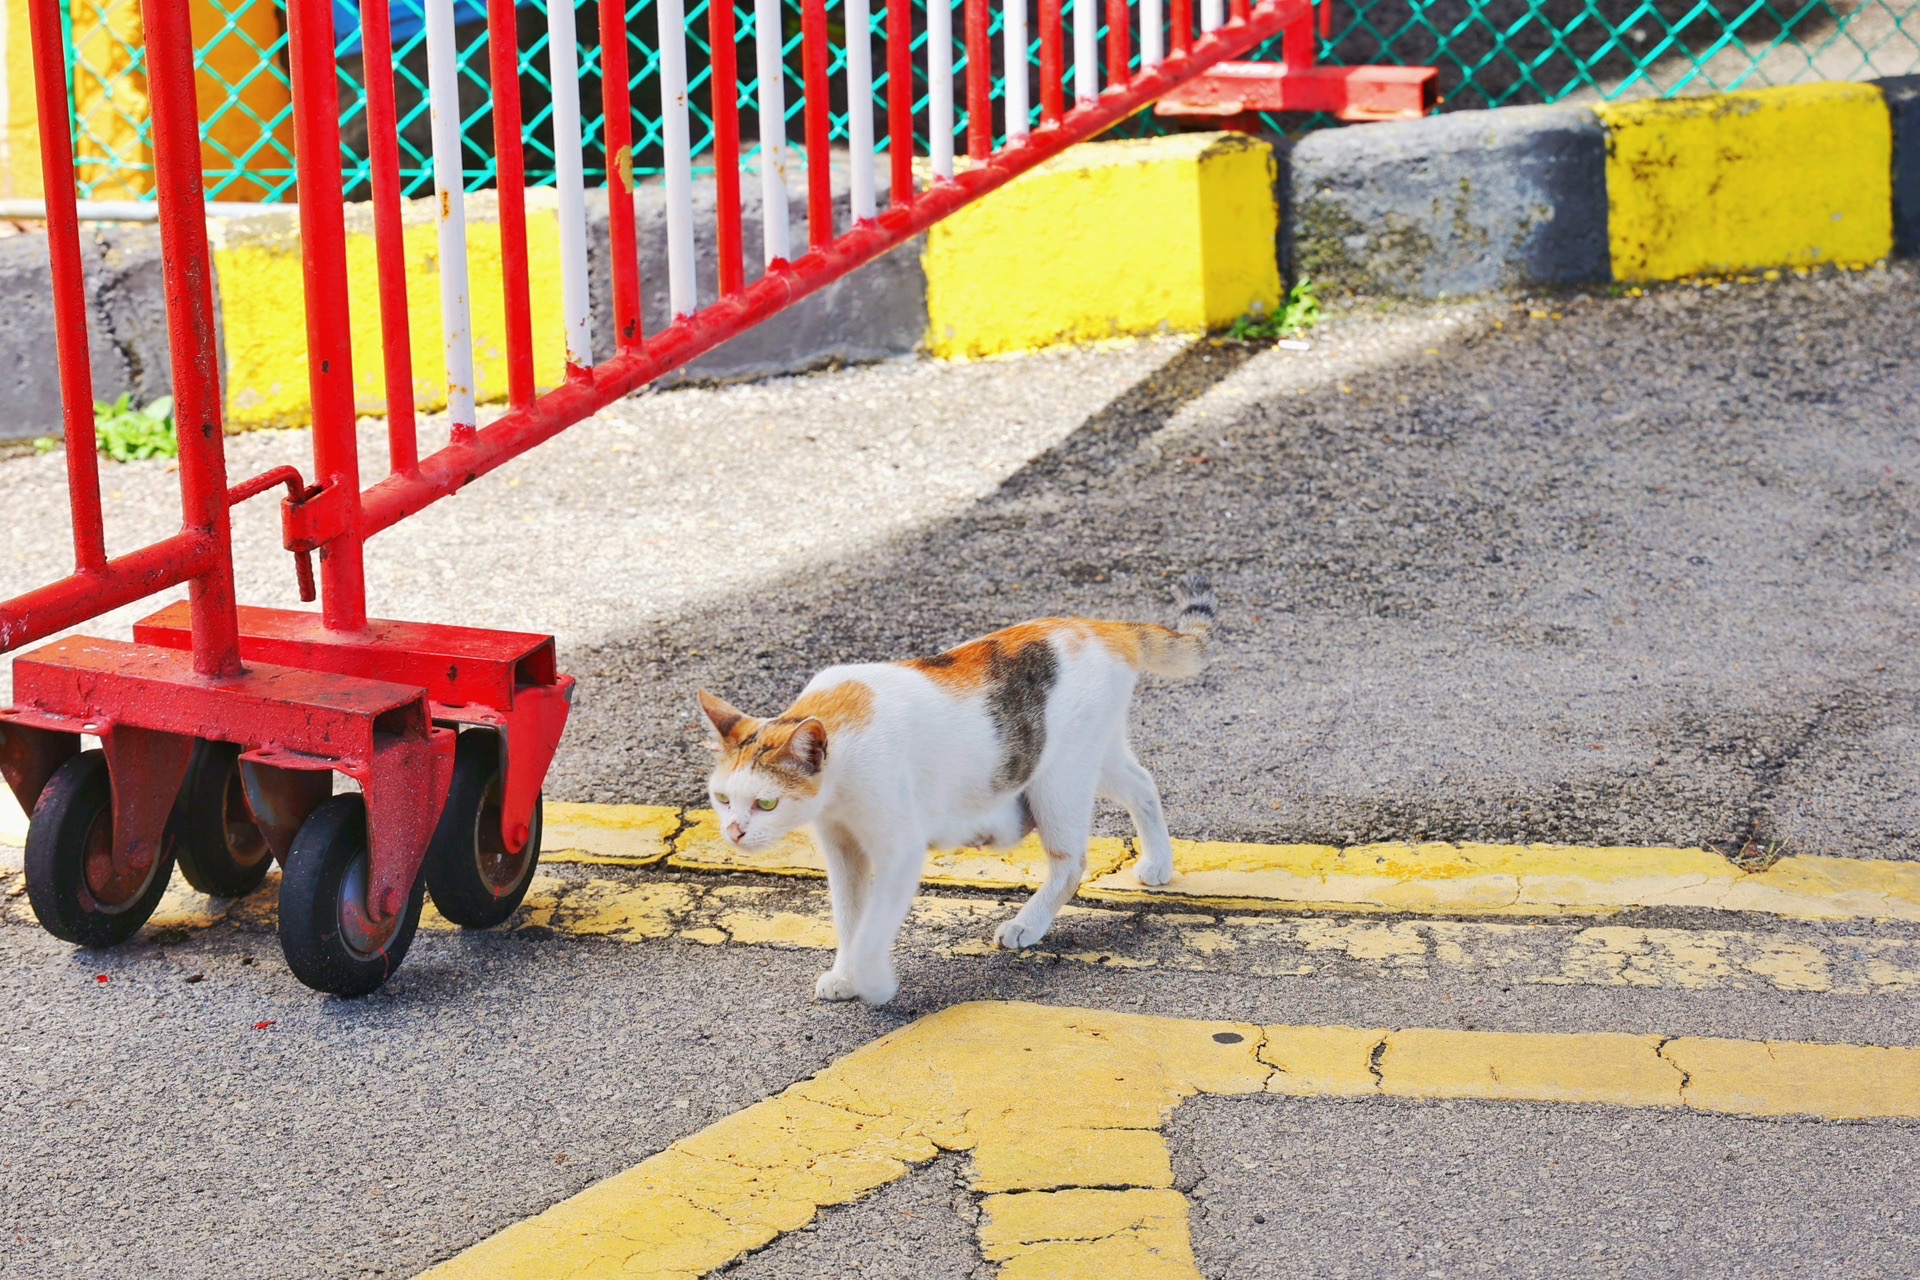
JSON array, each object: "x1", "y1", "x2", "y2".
[{"x1": 27, "y1": 750, "x2": 173, "y2": 946}]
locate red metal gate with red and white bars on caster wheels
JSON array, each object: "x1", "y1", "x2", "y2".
[{"x1": 0, "y1": 0, "x2": 1428, "y2": 994}]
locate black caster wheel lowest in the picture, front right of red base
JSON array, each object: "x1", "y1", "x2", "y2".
[{"x1": 280, "y1": 794, "x2": 424, "y2": 996}]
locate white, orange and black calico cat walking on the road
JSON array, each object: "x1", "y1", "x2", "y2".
[{"x1": 699, "y1": 576, "x2": 1213, "y2": 1004}]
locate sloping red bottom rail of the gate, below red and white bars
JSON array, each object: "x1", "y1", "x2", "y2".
[{"x1": 359, "y1": 0, "x2": 1308, "y2": 537}]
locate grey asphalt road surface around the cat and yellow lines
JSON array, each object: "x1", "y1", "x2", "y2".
[{"x1": 0, "y1": 265, "x2": 1920, "y2": 1280}]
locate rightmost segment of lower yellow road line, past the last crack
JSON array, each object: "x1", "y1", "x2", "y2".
[{"x1": 1661, "y1": 1036, "x2": 1920, "y2": 1121}]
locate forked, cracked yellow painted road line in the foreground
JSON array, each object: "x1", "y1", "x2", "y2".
[{"x1": 412, "y1": 1004, "x2": 1920, "y2": 1280}]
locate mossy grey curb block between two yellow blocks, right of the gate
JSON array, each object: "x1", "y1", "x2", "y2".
[{"x1": 1286, "y1": 107, "x2": 1607, "y2": 297}]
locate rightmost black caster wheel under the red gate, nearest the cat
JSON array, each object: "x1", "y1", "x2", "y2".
[{"x1": 426, "y1": 729, "x2": 541, "y2": 929}]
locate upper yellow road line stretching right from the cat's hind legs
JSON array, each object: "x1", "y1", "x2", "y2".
[{"x1": 1081, "y1": 841, "x2": 1920, "y2": 919}]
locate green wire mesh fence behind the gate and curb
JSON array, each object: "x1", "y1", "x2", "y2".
[{"x1": 52, "y1": 0, "x2": 1920, "y2": 201}]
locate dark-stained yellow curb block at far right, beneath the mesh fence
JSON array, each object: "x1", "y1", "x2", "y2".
[{"x1": 1599, "y1": 84, "x2": 1893, "y2": 280}]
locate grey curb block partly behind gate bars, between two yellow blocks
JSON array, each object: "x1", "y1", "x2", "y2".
[{"x1": 588, "y1": 169, "x2": 927, "y2": 386}]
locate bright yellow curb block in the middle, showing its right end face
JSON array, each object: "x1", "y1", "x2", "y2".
[{"x1": 925, "y1": 134, "x2": 1281, "y2": 359}]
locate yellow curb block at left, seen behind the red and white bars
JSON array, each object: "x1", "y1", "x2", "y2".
[{"x1": 211, "y1": 188, "x2": 566, "y2": 428}]
